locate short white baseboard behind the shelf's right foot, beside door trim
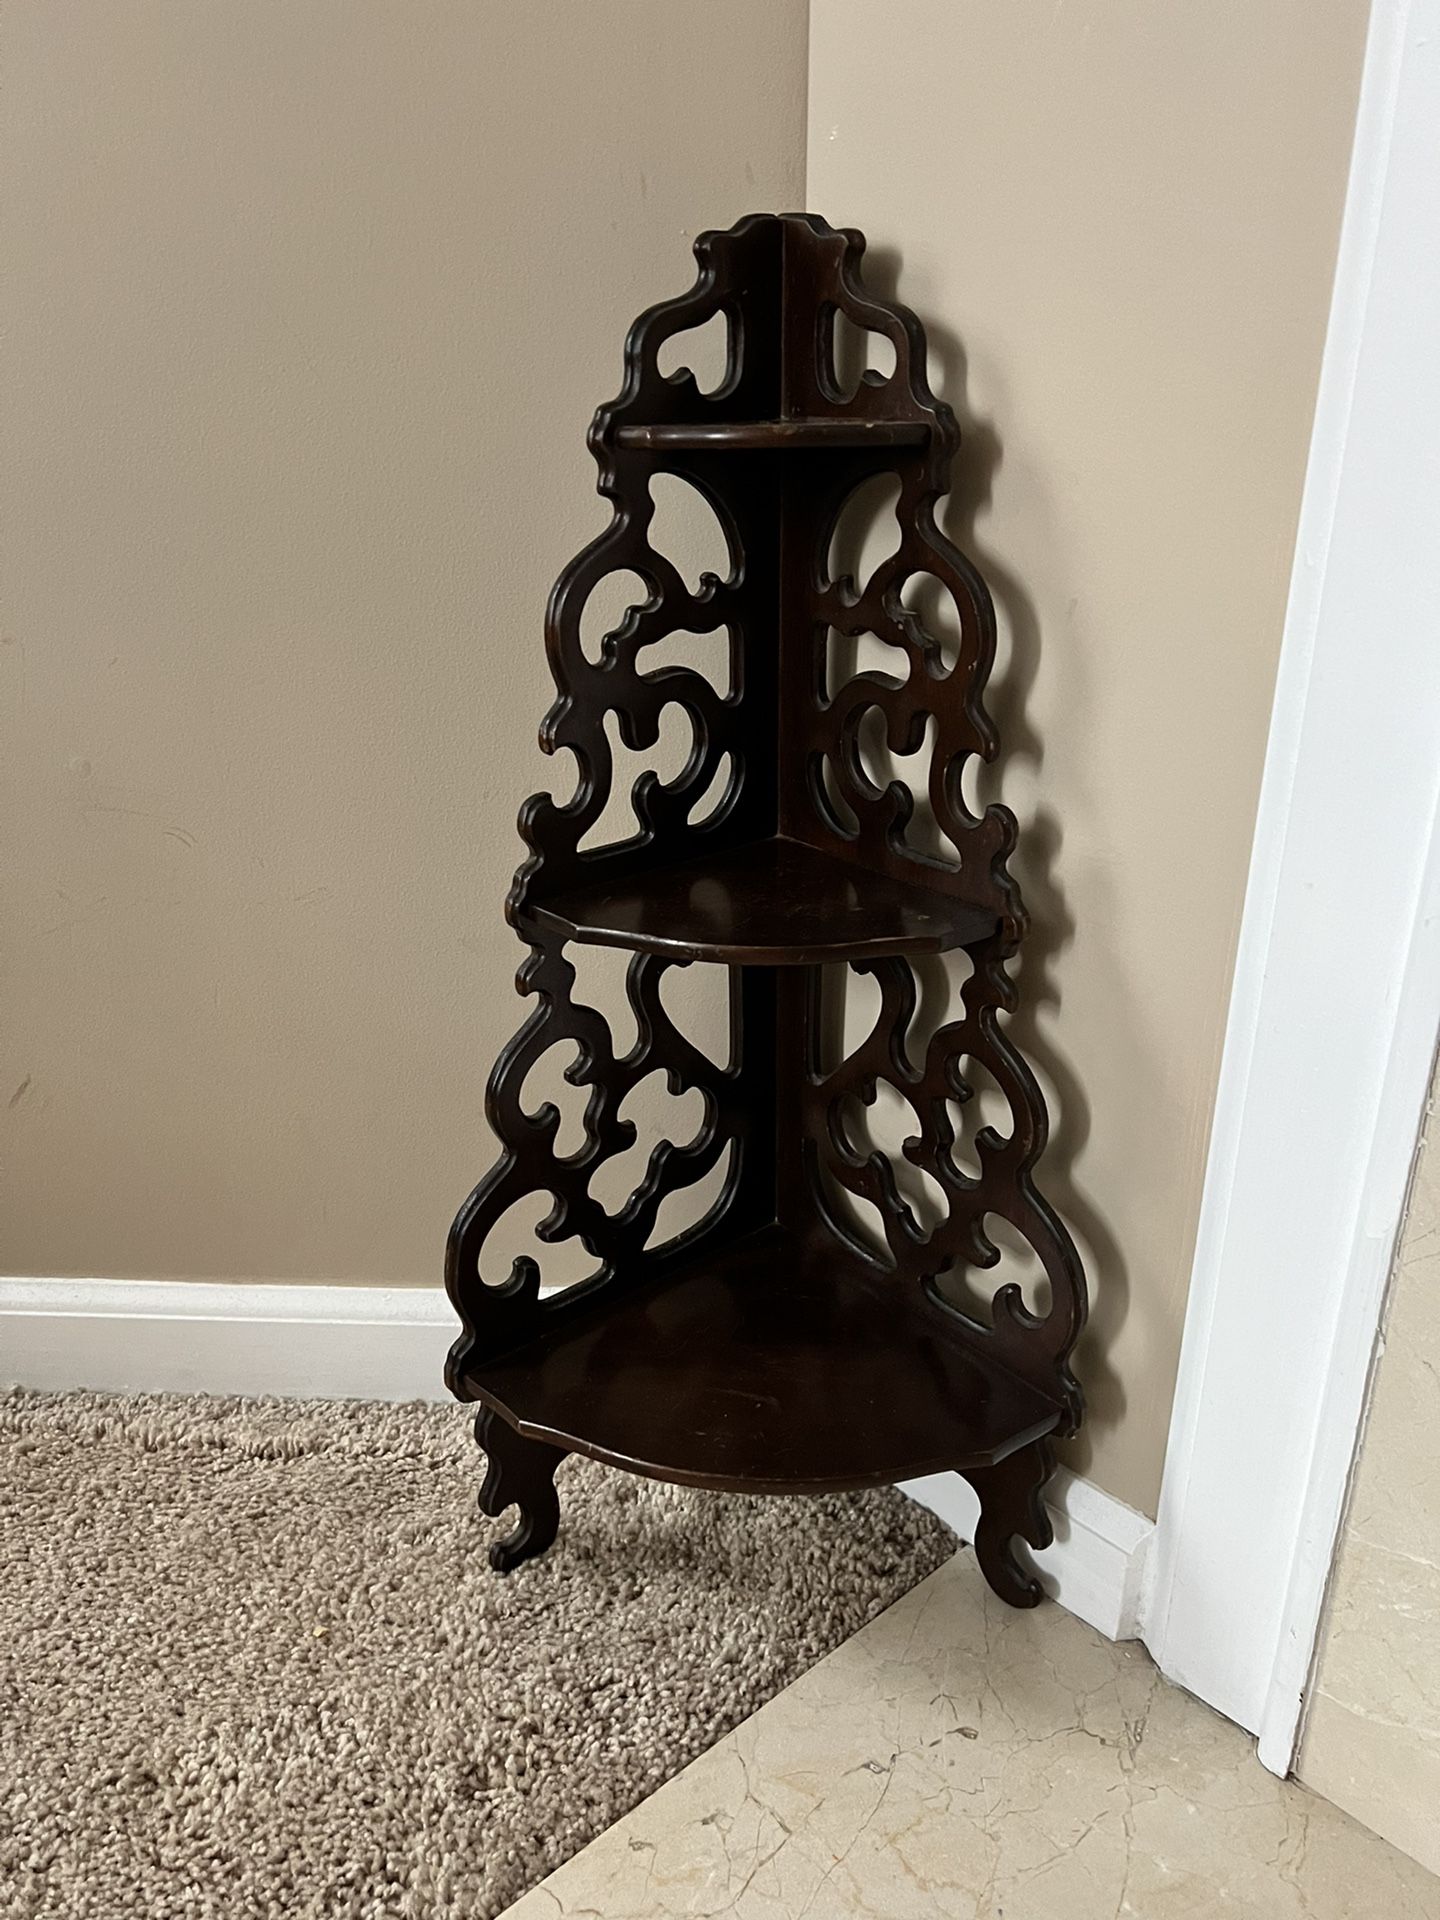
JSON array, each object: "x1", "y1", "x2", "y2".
[{"x1": 902, "y1": 1467, "x2": 1156, "y2": 1640}]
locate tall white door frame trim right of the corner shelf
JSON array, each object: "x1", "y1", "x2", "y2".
[{"x1": 1144, "y1": 0, "x2": 1440, "y2": 1772}]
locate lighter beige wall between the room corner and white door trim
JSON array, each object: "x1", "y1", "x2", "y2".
[{"x1": 808, "y1": 0, "x2": 1367, "y2": 1511}]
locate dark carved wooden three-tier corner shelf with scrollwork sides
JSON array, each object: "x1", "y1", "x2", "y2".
[{"x1": 445, "y1": 213, "x2": 1085, "y2": 1605}]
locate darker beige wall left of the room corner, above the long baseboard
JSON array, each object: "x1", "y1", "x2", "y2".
[{"x1": 0, "y1": 0, "x2": 806, "y2": 1283}]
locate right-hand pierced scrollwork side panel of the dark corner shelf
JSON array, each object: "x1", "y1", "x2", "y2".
[{"x1": 789, "y1": 220, "x2": 1085, "y2": 1428}]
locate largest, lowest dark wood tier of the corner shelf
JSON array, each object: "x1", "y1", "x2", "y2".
[{"x1": 463, "y1": 1229, "x2": 1062, "y2": 1494}]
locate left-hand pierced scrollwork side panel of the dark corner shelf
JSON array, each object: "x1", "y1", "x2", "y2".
[{"x1": 445, "y1": 236, "x2": 791, "y2": 1396}]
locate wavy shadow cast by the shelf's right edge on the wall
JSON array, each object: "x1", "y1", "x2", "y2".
[{"x1": 864, "y1": 236, "x2": 1131, "y2": 1473}]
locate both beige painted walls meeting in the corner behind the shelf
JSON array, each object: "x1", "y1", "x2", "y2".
[{"x1": 0, "y1": 0, "x2": 1365, "y2": 1509}]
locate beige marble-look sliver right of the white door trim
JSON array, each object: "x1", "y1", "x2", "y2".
[{"x1": 1298, "y1": 1052, "x2": 1440, "y2": 1874}]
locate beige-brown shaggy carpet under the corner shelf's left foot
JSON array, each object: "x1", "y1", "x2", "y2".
[{"x1": 0, "y1": 1394, "x2": 954, "y2": 1920}]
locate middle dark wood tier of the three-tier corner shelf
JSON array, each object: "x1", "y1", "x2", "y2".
[{"x1": 530, "y1": 837, "x2": 995, "y2": 966}]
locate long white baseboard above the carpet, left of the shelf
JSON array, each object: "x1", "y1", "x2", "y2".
[{"x1": 0, "y1": 1279, "x2": 459, "y2": 1400}]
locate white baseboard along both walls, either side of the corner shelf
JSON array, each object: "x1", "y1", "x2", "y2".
[{"x1": 0, "y1": 1279, "x2": 1154, "y2": 1640}]
